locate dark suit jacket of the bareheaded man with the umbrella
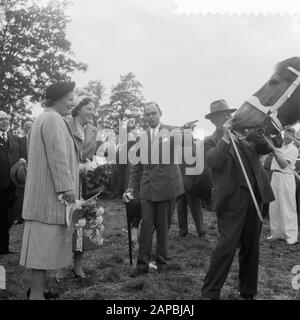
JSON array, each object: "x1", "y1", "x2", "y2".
[{"x1": 128, "y1": 124, "x2": 184, "y2": 201}]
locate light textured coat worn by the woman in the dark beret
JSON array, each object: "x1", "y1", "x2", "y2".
[{"x1": 22, "y1": 108, "x2": 79, "y2": 225}]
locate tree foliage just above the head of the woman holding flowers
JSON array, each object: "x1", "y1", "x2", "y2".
[{"x1": 76, "y1": 79, "x2": 105, "y2": 124}]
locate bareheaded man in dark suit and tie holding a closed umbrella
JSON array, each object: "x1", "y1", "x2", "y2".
[{"x1": 127, "y1": 102, "x2": 184, "y2": 277}]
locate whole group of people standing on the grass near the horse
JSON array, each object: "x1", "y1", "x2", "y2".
[{"x1": 0, "y1": 82, "x2": 300, "y2": 300}]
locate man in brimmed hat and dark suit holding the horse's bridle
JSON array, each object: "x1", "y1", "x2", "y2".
[{"x1": 202, "y1": 100, "x2": 280, "y2": 300}]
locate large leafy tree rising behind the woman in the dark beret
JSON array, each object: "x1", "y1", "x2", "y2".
[{"x1": 0, "y1": 0, "x2": 87, "y2": 129}]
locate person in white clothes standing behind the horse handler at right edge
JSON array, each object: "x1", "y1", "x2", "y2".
[{"x1": 267, "y1": 128, "x2": 298, "y2": 244}]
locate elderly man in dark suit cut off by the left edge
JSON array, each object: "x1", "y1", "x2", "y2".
[{"x1": 0, "y1": 111, "x2": 20, "y2": 254}]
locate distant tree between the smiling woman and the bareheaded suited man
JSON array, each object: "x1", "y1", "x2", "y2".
[{"x1": 99, "y1": 72, "x2": 145, "y2": 134}]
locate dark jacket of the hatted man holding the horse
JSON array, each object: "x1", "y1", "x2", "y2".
[{"x1": 205, "y1": 131, "x2": 274, "y2": 213}]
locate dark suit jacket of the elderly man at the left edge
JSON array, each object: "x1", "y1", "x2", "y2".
[{"x1": 0, "y1": 133, "x2": 21, "y2": 190}]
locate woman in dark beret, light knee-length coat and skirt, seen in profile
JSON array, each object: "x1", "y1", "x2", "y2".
[{"x1": 20, "y1": 82, "x2": 79, "y2": 300}]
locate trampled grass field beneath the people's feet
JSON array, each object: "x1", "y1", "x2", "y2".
[{"x1": 0, "y1": 200, "x2": 300, "y2": 300}]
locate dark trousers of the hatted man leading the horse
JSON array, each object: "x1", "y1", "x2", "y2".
[{"x1": 202, "y1": 186, "x2": 261, "y2": 299}]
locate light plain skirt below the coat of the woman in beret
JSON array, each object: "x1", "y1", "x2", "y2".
[{"x1": 20, "y1": 220, "x2": 72, "y2": 270}]
